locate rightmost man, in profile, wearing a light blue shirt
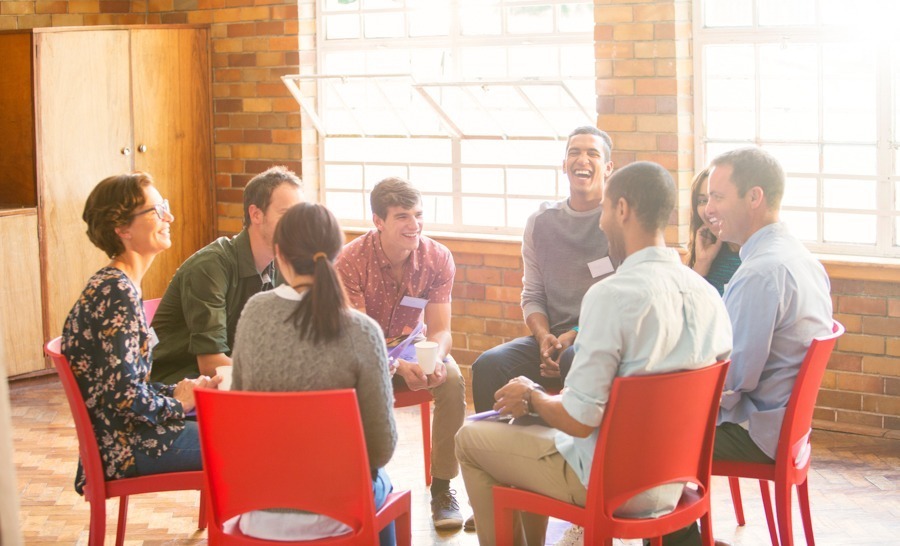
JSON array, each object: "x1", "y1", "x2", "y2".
[{"x1": 664, "y1": 148, "x2": 832, "y2": 546}]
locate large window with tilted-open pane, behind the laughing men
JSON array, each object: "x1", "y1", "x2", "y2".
[{"x1": 310, "y1": 0, "x2": 596, "y2": 234}]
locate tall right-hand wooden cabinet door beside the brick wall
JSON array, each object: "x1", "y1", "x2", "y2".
[{"x1": 131, "y1": 29, "x2": 214, "y2": 298}]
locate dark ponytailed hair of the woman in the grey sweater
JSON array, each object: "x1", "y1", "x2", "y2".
[{"x1": 273, "y1": 203, "x2": 349, "y2": 343}]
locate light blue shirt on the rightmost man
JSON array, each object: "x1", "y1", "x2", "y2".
[{"x1": 719, "y1": 223, "x2": 832, "y2": 458}]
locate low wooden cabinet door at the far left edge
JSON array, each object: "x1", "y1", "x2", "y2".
[{"x1": 0, "y1": 212, "x2": 44, "y2": 376}]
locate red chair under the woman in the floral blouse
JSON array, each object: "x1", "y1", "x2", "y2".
[{"x1": 44, "y1": 337, "x2": 206, "y2": 546}]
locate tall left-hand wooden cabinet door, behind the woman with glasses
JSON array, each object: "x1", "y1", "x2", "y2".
[{"x1": 35, "y1": 30, "x2": 132, "y2": 337}]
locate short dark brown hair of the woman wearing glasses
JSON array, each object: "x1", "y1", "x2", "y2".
[{"x1": 81, "y1": 172, "x2": 153, "y2": 258}]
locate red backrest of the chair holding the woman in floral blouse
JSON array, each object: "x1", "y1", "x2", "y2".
[{"x1": 44, "y1": 337, "x2": 106, "y2": 501}]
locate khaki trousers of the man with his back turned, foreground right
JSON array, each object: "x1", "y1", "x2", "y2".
[{"x1": 456, "y1": 421, "x2": 587, "y2": 546}]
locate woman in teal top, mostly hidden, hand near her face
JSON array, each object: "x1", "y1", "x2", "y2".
[{"x1": 687, "y1": 169, "x2": 741, "y2": 295}]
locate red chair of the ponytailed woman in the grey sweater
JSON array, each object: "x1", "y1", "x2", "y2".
[{"x1": 194, "y1": 389, "x2": 412, "y2": 546}]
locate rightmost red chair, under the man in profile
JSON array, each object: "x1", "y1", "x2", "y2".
[{"x1": 713, "y1": 321, "x2": 844, "y2": 546}]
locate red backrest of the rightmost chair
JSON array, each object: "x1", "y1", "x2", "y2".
[{"x1": 775, "y1": 321, "x2": 844, "y2": 470}]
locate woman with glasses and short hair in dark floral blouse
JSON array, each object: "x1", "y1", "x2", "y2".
[{"x1": 62, "y1": 172, "x2": 218, "y2": 493}]
